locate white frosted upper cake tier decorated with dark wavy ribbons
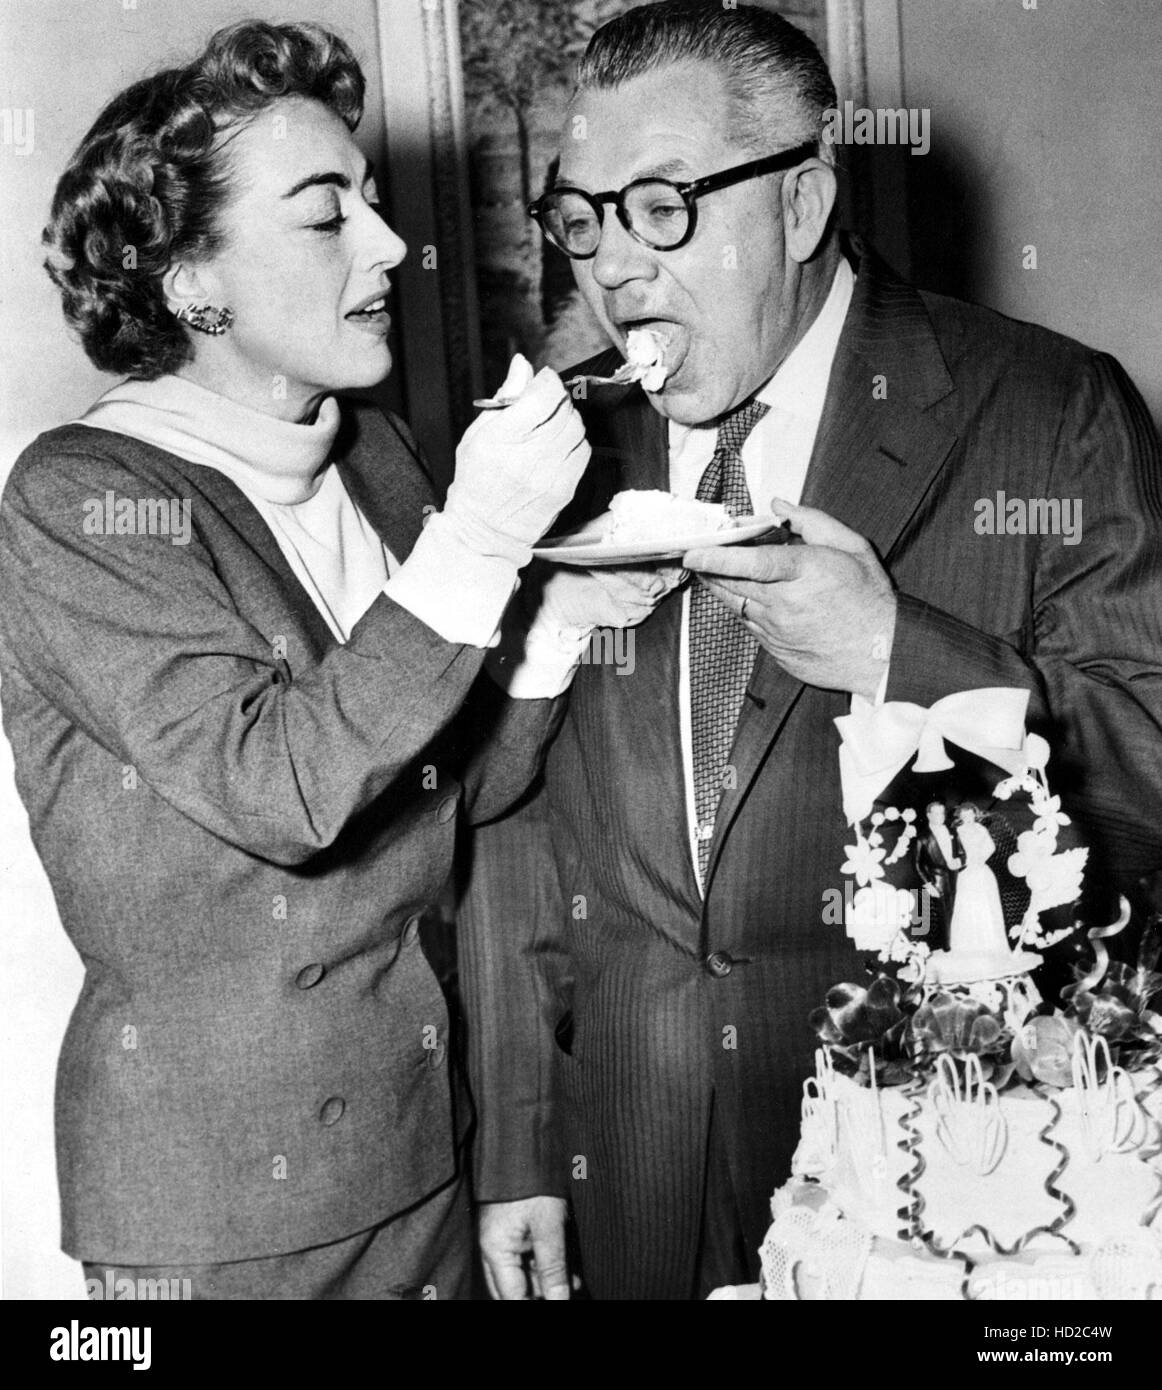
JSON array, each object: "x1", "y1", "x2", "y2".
[{"x1": 769, "y1": 1033, "x2": 1162, "y2": 1297}]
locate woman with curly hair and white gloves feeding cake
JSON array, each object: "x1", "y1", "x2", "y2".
[{"x1": 0, "y1": 24, "x2": 656, "y2": 1298}]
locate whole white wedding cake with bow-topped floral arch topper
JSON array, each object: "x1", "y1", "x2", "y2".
[{"x1": 760, "y1": 689, "x2": 1162, "y2": 1300}]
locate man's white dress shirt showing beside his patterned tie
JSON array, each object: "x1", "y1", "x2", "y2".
[{"x1": 670, "y1": 259, "x2": 855, "y2": 888}]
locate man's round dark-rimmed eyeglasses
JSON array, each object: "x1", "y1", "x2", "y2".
[{"x1": 528, "y1": 140, "x2": 816, "y2": 260}]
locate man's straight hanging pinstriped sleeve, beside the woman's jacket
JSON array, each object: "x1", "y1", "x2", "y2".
[{"x1": 457, "y1": 772, "x2": 570, "y2": 1202}]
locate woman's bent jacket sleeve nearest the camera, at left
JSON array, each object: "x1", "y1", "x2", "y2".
[{"x1": 0, "y1": 446, "x2": 494, "y2": 865}]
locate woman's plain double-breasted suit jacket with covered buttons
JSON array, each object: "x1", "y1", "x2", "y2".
[{"x1": 0, "y1": 402, "x2": 560, "y2": 1265}]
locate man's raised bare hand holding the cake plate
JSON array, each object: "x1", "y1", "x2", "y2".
[{"x1": 682, "y1": 498, "x2": 895, "y2": 699}]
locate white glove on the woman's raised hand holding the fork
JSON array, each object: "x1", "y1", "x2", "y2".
[{"x1": 442, "y1": 353, "x2": 589, "y2": 566}]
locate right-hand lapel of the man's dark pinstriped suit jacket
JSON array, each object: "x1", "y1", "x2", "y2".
[{"x1": 706, "y1": 254, "x2": 956, "y2": 894}]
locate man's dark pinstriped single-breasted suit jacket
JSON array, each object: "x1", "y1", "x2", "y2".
[{"x1": 460, "y1": 244, "x2": 1162, "y2": 1297}]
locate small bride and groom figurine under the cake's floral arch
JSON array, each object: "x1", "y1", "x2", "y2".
[{"x1": 913, "y1": 801, "x2": 1012, "y2": 960}]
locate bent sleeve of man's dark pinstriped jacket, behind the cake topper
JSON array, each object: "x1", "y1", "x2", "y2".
[{"x1": 885, "y1": 353, "x2": 1162, "y2": 883}]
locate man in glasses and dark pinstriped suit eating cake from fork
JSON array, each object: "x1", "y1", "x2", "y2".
[{"x1": 463, "y1": 3, "x2": 1162, "y2": 1298}]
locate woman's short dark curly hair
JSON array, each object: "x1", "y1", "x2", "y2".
[{"x1": 43, "y1": 21, "x2": 364, "y2": 381}]
